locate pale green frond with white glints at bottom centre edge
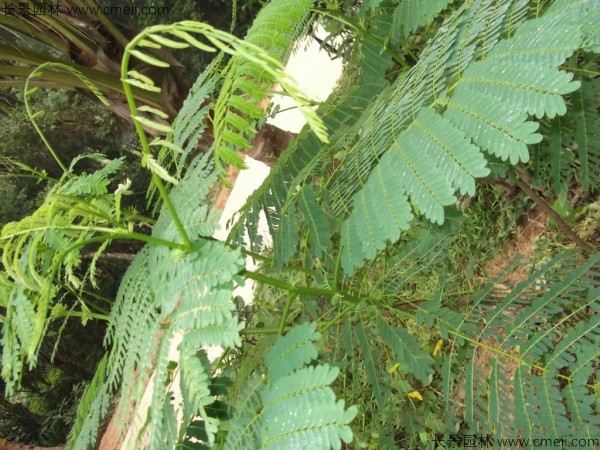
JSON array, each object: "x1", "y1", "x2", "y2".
[{"x1": 223, "y1": 323, "x2": 357, "y2": 450}]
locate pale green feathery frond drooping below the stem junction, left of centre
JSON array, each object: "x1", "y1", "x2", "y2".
[{"x1": 68, "y1": 152, "x2": 242, "y2": 449}]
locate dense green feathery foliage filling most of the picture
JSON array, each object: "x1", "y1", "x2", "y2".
[{"x1": 0, "y1": 0, "x2": 600, "y2": 449}]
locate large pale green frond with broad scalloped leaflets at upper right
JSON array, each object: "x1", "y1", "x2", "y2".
[{"x1": 332, "y1": 1, "x2": 582, "y2": 274}]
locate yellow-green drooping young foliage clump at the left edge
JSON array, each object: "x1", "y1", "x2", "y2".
[{"x1": 0, "y1": 158, "x2": 131, "y2": 392}]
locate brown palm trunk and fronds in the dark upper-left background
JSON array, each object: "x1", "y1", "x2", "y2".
[{"x1": 0, "y1": 0, "x2": 293, "y2": 165}]
